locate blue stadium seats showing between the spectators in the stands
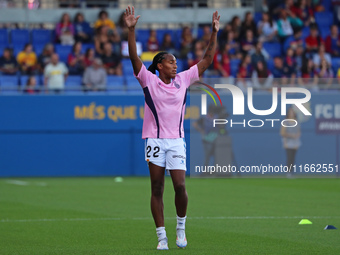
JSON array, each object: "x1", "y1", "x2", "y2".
[{"x1": 0, "y1": 0, "x2": 340, "y2": 93}]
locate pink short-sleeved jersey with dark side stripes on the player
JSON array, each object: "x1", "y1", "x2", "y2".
[{"x1": 136, "y1": 65, "x2": 199, "y2": 139}]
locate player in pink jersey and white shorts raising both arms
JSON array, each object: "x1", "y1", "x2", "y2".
[{"x1": 124, "y1": 6, "x2": 220, "y2": 250}]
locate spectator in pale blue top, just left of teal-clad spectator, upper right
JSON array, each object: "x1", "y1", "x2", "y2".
[{"x1": 257, "y1": 13, "x2": 277, "y2": 42}]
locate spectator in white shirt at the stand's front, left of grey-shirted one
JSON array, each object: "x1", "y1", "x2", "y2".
[{"x1": 44, "y1": 53, "x2": 68, "y2": 92}]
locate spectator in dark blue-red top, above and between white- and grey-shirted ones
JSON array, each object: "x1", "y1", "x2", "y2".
[{"x1": 67, "y1": 42, "x2": 85, "y2": 75}]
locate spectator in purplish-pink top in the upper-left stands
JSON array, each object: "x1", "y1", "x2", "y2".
[{"x1": 55, "y1": 13, "x2": 74, "y2": 45}]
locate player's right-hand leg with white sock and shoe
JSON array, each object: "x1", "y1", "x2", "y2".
[{"x1": 170, "y1": 170, "x2": 188, "y2": 248}]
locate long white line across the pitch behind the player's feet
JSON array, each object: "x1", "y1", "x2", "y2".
[{"x1": 0, "y1": 216, "x2": 340, "y2": 223}]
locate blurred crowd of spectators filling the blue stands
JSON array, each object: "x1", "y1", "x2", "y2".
[{"x1": 0, "y1": 0, "x2": 340, "y2": 91}]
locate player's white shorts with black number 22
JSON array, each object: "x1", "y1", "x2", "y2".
[{"x1": 145, "y1": 138, "x2": 187, "y2": 171}]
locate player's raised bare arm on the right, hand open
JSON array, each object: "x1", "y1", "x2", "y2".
[{"x1": 197, "y1": 11, "x2": 220, "y2": 76}]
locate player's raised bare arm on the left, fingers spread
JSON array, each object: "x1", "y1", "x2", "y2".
[{"x1": 124, "y1": 6, "x2": 143, "y2": 75}]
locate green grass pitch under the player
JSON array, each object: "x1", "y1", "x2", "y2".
[{"x1": 0, "y1": 178, "x2": 340, "y2": 255}]
